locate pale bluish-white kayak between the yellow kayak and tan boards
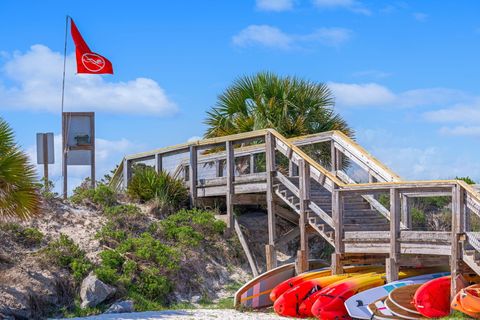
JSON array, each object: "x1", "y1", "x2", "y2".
[{"x1": 345, "y1": 272, "x2": 450, "y2": 319}]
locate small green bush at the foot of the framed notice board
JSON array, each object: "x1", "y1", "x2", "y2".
[{"x1": 70, "y1": 178, "x2": 117, "y2": 208}]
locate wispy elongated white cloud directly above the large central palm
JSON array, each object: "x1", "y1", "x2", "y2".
[{"x1": 232, "y1": 25, "x2": 352, "y2": 50}]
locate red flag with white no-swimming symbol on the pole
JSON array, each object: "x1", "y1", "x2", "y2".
[{"x1": 70, "y1": 18, "x2": 113, "y2": 74}]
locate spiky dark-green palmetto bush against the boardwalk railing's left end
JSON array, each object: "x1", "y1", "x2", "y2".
[{"x1": 127, "y1": 167, "x2": 188, "y2": 210}]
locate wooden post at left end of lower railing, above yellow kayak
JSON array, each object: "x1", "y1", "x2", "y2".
[{"x1": 332, "y1": 189, "x2": 345, "y2": 274}]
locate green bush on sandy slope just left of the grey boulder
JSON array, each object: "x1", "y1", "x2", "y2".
[{"x1": 44, "y1": 234, "x2": 92, "y2": 281}]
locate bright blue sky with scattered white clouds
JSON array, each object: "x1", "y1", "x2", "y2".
[{"x1": 0, "y1": 0, "x2": 480, "y2": 190}]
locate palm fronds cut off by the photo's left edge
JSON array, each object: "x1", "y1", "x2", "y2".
[{"x1": 0, "y1": 118, "x2": 40, "y2": 219}]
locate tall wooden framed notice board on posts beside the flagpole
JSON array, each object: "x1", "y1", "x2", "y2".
[{"x1": 62, "y1": 112, "x2": 95, "y2": 199}]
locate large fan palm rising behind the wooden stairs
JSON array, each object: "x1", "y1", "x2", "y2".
[{"x1": 205, "y1": 72, "x2": 353, "y2": 169}]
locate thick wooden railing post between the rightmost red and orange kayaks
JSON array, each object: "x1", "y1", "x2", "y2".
[{"x1": 450, "y1": 184, "x2": 465, "y2": 299}]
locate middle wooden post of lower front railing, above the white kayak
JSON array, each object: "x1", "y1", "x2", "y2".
[{"x1": 385, "y1": 188, "x2": 401, "y2": 282}]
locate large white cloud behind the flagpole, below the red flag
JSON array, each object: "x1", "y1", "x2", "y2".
[{"x1": 0, "y1": 44, "x2": 177, "y2": 116}]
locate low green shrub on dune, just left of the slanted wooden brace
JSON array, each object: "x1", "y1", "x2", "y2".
[{"x1": 159, "y1": 209, "x2": 226, "y2": 246}]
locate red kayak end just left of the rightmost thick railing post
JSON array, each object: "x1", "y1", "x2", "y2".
[{"x1": 413, "y1": 276, "x2": 451, "y2": 318}]
